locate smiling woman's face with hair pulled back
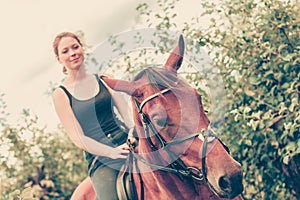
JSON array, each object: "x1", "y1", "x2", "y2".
[{"x1": 57, "y1": 37, "x2": 84, "y2": 70}]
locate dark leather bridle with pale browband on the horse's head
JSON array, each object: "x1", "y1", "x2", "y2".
[{"x1": 131, "y1": 88, "x2": 229, "y2": 186}]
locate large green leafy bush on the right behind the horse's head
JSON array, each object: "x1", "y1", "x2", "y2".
[{"x1": 138, "y1": 0, "x2": 300, "y2": 199}]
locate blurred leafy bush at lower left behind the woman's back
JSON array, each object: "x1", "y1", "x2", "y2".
[{"x1": 0, "y1": 110, "x2": 87, "y2": 200}]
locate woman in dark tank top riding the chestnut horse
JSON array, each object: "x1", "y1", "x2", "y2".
[{"x1": 53, "y1": 32, "x2": 134, "y2": 200}]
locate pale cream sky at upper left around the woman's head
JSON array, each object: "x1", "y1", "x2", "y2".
[{"x1": 0, "y1": 0, "x2": 209, "y2": 130}]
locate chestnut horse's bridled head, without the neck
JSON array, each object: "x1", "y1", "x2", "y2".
[{"x1": 104, "y1": 34, "x2": 243, "y2": 198}]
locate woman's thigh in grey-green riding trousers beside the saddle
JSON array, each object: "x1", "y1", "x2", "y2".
[{"x1": 91, "y1": 166, "x2": 119, "y2": 200}]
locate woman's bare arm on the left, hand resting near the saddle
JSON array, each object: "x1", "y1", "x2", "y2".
[{"x1": 52, "y1": 89, "x2": 128, "y2": 159}]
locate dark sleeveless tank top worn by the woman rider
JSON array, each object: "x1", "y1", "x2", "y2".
[{"x1": 59, "y1": 75, "x2": 127, "y2": 174}]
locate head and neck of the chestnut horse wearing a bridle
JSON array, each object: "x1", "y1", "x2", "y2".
[{"x1": 104, "y1": 35, "x2": 243, "y2": 200}]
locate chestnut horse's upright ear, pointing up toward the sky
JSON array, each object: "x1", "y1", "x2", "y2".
[{"x1": 165, "y1": 35, "x2": 184, "y2": 72}]
